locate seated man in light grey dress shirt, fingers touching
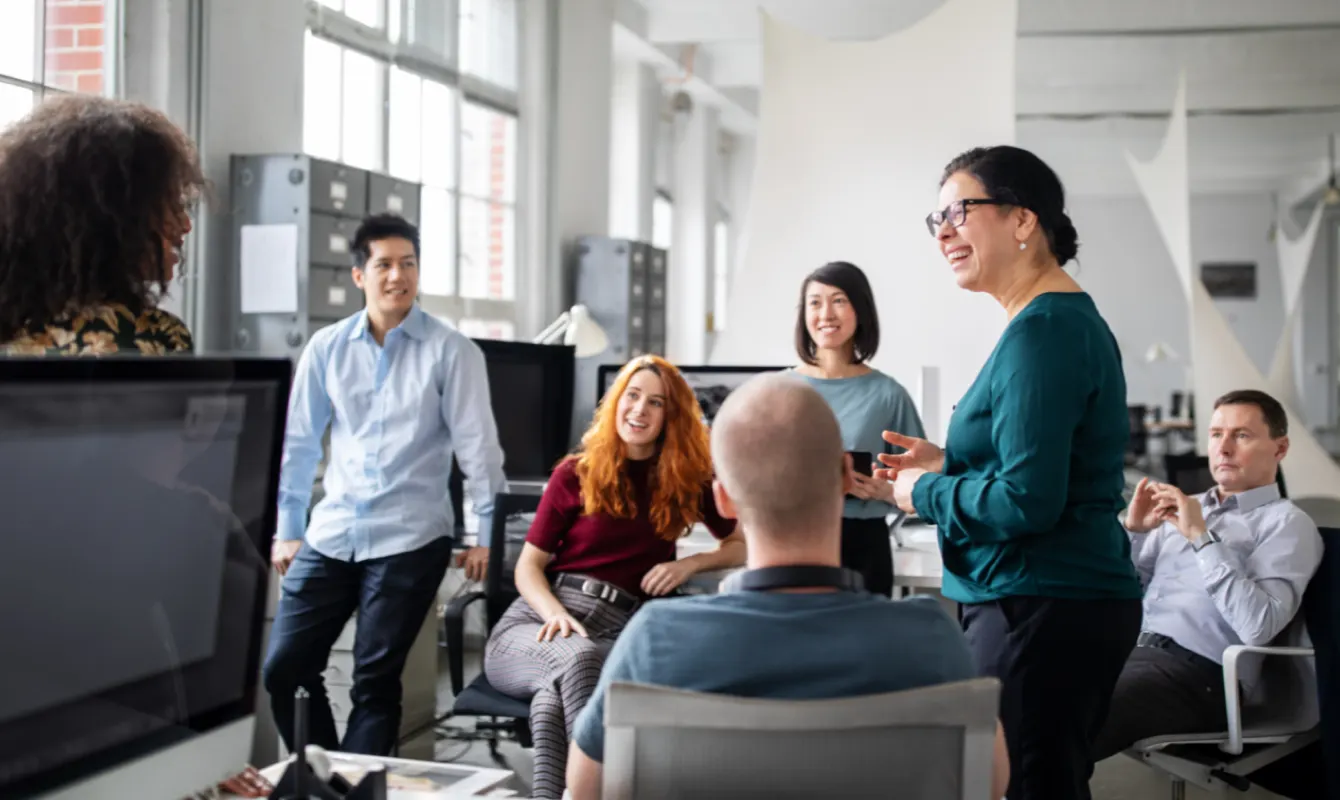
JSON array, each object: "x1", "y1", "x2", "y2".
[{"x1": 1093, "y1": 391, "x2": 1321, "y2": 760}]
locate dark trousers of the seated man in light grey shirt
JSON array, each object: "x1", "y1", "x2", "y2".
[{"x1": 1093, "y1": 647, "x2": 1229, "y2": 761}]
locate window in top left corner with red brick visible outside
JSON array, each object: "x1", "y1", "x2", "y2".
[{"x1": 0, "y1": 0, "x2": 117, "y2": 127}]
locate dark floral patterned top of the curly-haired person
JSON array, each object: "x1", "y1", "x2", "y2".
[{"x1": 0, "y1": 304, "x2": 196, "y2": 355}]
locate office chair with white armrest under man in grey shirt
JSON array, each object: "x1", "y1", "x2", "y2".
[{"x1": 1126, "y1": 528, "x2": 1340, "y2": 800}]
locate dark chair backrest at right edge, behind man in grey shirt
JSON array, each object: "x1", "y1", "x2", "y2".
[{"x1": 1302, "y1": 528, "x2": 1340, "y2": 797}]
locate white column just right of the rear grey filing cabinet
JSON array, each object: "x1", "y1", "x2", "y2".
[{"x1": 666, "y1": 105, "x2": 720, "y2": 364}]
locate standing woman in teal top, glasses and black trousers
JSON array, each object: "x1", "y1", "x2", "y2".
[{"x1": 879, "y1": 147, "x2": 1140, "y2": 800}]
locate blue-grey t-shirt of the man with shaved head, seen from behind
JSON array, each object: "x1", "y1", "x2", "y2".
[{"x1": 572, "y1": 591, "x2": 976, "y2": 761}]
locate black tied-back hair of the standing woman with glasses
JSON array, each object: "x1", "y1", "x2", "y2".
[{"x1": 939, "y1": 145, "x2": 1080, "y2": 267}]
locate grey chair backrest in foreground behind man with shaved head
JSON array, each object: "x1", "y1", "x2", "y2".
[{"x1": 603, "y1": 678, "x2": 1000, "y2": 800}]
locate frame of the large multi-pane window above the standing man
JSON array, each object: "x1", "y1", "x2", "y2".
[{"x1": 304, "y1": 0, "x2": 525, "y2": 332}]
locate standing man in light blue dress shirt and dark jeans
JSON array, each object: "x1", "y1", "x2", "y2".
[{"x1": 264, "y1": 214, "x2": 505, "y2": 756}]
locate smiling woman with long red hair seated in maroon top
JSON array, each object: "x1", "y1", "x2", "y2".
[{"x1": 484, "y1": 355, "x2": 745, "y2": 797}]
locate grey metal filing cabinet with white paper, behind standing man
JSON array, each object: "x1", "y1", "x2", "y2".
[{"x1": 232, "y1": 154, "x2": 419, "y2": 359}]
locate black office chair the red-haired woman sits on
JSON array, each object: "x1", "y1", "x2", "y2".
[{"x1": 442, "y1": 492, "x2": 540, "y2": 768}]
